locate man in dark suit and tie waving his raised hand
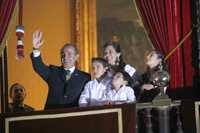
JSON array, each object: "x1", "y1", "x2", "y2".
[{"x1": 31, "y1": 31, "x2": 90, "y2": 109}]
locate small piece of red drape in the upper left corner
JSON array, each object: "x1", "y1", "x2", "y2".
[{"x1": 0, "y1": 0, "x2": 17, "y2": 43}]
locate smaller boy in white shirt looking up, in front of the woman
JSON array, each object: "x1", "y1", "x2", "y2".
[{"x1": 106, "y1": 71, "x2": 136, "y2": 104}]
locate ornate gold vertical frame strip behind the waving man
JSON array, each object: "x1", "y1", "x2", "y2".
[{"x1": 75, "y1": 0, "x2": 97, "y2": 72}]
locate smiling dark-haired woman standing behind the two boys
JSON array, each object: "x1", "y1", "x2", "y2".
[{"x1": 104, "y1": 41, "x2": 140, "y2": 98}]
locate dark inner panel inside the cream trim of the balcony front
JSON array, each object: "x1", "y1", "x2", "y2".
[{"x1": 6, "y1": 110, "x2": 120, "y2": 133}]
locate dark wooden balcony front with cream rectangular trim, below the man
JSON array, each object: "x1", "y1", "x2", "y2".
[{"x1": 0, "y1": 104, "x2": 135, "y2": 133}]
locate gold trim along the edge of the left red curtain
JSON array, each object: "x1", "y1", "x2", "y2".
[{"x1": 0, "y1": 0, "x2": 19, "y2": 56}]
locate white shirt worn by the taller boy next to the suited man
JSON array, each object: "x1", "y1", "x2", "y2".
[{"x1": 79, "y1": 77, "x2": 111, "y2": 106}]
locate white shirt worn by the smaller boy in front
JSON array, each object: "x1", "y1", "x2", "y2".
[{"x1": 105, "y1": 85, "x2": 135, "y2": 103}]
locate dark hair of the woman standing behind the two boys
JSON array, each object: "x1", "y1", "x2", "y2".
[{"x1": 103, "y1": 41, "x2": 126, "y2": 69}]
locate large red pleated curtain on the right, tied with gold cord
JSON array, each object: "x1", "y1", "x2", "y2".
[{"x1": 136, "y1": 0, "x2": 192, "y2": 89}]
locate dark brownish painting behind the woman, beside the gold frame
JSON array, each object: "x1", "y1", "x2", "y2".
[{"x1": 97, "y1": 0, "x2": 153, "y2": 73}]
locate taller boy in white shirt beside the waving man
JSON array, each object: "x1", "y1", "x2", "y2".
[{"x1": 79, "y1": 57, "x2": 111, "y2": 107}]
